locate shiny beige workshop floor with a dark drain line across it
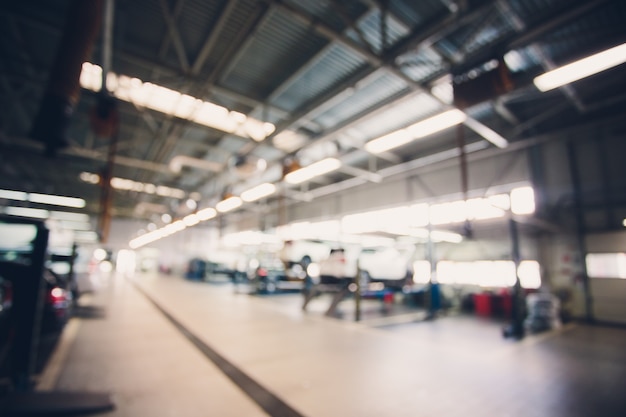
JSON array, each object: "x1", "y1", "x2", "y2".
[{"x1": 31, "y1": 275, "x2": 626, "y2": 417}]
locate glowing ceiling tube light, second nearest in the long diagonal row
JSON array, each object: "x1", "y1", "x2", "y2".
[{"x1": 365, "y1": 109, "x2": 467, "y2": 153}]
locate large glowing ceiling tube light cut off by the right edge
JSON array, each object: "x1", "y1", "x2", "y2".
[{"x1": 533, "y1": 43, "x2": 626, "y2": 91}]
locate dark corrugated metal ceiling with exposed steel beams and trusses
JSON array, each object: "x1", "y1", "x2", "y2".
[{"x1": 0, "y1": 0, "x2": 626, "y2": 242}]
